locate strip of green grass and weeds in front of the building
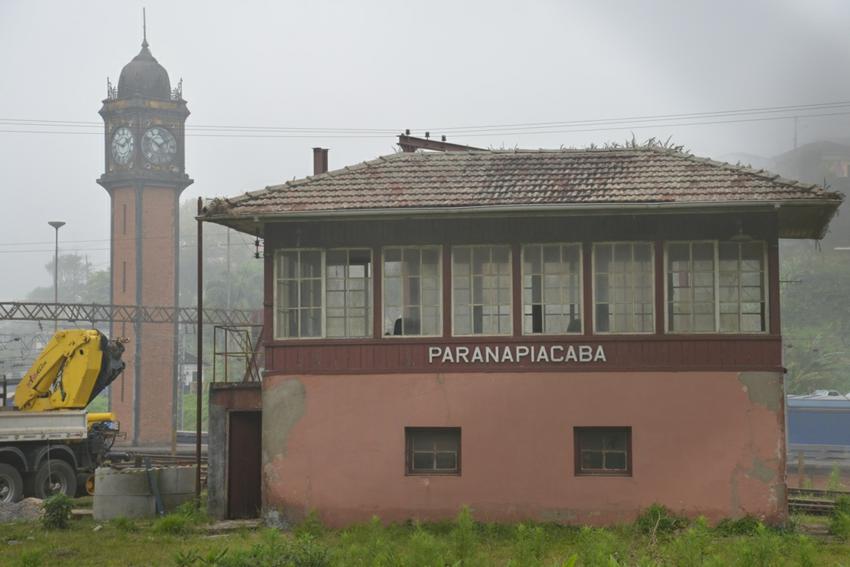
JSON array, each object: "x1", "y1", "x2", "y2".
[{"x1": 0, "y1": 508, "x2": 850, "y2": 567}]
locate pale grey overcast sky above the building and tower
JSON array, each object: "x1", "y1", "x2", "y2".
[{"x1": 0, "y1": 0, "x2": 850, "y2": 301}]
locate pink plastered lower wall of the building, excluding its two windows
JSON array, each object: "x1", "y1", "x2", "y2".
[{"x1": 263, "y1": 372, "x2": 785, "y2": 525}]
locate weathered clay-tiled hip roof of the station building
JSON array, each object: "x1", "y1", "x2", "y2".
[{"x1": 203, "y1": 147, "x2": 842, "y2": 220}]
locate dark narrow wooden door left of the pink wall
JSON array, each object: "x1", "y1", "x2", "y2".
[{"x1": 227, "y1": 411, "x2": 262, "y2": 519}]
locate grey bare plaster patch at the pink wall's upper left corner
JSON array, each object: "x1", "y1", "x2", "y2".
[{"x1": 263, "y1": 378, "x2": 307, "y2": 465}]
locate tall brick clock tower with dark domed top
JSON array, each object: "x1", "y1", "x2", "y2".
[{"x1": 97, "y1": 30, "x2": 192, "y2": 445}]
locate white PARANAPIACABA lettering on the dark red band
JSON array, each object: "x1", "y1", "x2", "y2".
[{"x1": 428, "y1": 345, "x2": 608, "y2": 364}]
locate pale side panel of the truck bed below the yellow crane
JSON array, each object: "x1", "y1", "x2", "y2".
[{"x1": 0, "y1": 410, "x2": 88, "y2": 443}]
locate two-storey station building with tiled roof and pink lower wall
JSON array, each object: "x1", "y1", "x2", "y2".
[{"x1": 201, "y1": 147, "x2": 841, "y2": 525}]
